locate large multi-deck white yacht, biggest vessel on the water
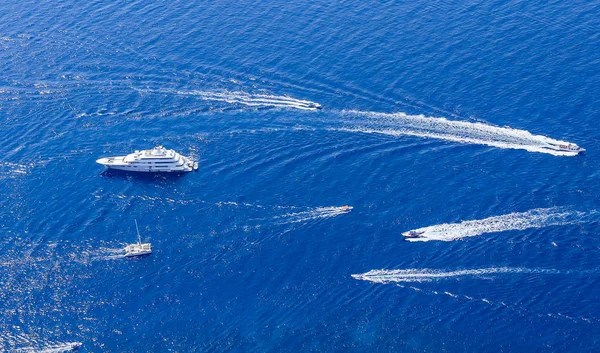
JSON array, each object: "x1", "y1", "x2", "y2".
[{"x1": 96, "y1": 146, "x2": 198, "y2": 173}]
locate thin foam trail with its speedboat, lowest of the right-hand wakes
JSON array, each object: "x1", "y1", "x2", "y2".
[{"x1": 352, "y1": 267, "x2": 558, "y2": 283}]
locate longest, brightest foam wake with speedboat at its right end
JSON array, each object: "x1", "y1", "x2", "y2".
[{"x1": 334, "y1": 111, "x2": 580, "y2": 156}]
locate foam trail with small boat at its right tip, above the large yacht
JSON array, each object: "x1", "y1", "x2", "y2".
[{"x1": 140, "y1": 90, "x2": 321, "y2": 110}]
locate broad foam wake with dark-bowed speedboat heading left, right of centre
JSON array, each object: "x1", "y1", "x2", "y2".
[{"x1": 402, "y1": 207, "x2": 587, "y2": 242}]
